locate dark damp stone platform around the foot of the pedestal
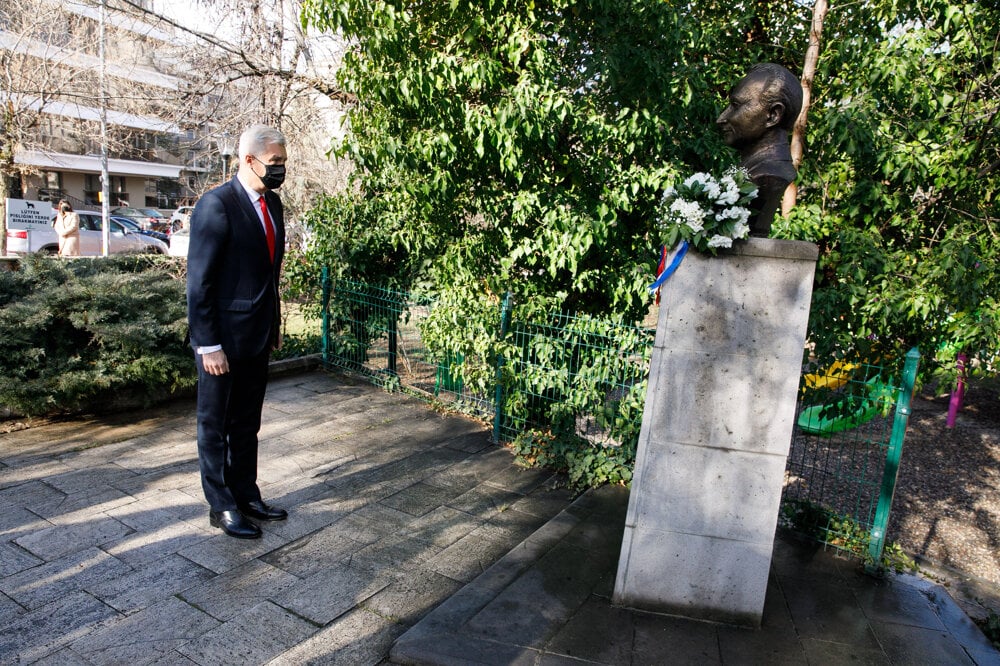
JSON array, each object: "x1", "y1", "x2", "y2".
[{"x1": 390, "y1": 487, "x2": 1000, "y2": 666}]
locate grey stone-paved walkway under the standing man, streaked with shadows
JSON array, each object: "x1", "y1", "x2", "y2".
[{"x1": 0, "y1": 372, "x2": 571, "y2": 666}]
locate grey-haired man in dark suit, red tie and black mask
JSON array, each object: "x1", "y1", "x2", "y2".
[{"x1": 187, "y1": 125, "x2": 288, "y2": 539}]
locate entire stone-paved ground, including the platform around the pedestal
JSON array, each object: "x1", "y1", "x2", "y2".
[{"x1": 0, "y1": 372, "x2": 1000, "y2": 666}]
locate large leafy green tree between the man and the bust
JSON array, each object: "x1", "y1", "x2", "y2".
[{"x1": 305, "y1": 0, "x2": 800, "y2": 320}]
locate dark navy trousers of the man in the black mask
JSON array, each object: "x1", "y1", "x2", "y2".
[{"x1": 195, "y1": 352, "x2": 270, "y2": 511}]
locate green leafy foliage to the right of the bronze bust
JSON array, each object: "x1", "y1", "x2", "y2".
[{"x1": 781, "y1": 0, "x2": 1000, "y2": 377}]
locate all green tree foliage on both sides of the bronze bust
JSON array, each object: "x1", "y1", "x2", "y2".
[{"x1": 303, "y1": 0, "x2": 1000, "y2": 382}]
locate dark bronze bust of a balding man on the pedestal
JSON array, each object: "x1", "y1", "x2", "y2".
[{"x1": 716, "y1": 63, "x2": 802, "y2": 238}]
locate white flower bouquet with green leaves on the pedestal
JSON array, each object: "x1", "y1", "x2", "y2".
[{"x1": 657, "y1": 167, "x2": 757, "y2": 255}]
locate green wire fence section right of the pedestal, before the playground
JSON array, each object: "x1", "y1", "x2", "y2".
[{"x1": 782, "y1": 349, "x2": 920, "y2": 566}]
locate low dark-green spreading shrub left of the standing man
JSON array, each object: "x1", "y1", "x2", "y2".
[{"x1": 0, "y1": 255, "x2": 196, "y2": 416}]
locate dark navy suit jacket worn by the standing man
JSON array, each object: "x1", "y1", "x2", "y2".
[{"x1": 187, "y1": 177, "x2": 285, "y2": 359}]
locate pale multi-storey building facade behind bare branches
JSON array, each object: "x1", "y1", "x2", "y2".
[{"x1": 0, "y1": 0, "x2": 224, "y2": 209}]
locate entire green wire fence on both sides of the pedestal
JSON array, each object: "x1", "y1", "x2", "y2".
[{"x1": 323, "y1": 270, "x2": 919, "y2": 565}]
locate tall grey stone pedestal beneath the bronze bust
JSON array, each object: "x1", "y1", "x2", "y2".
[{"x1": 614, "y1": 238, "x2": 817, "y2": 627}]
